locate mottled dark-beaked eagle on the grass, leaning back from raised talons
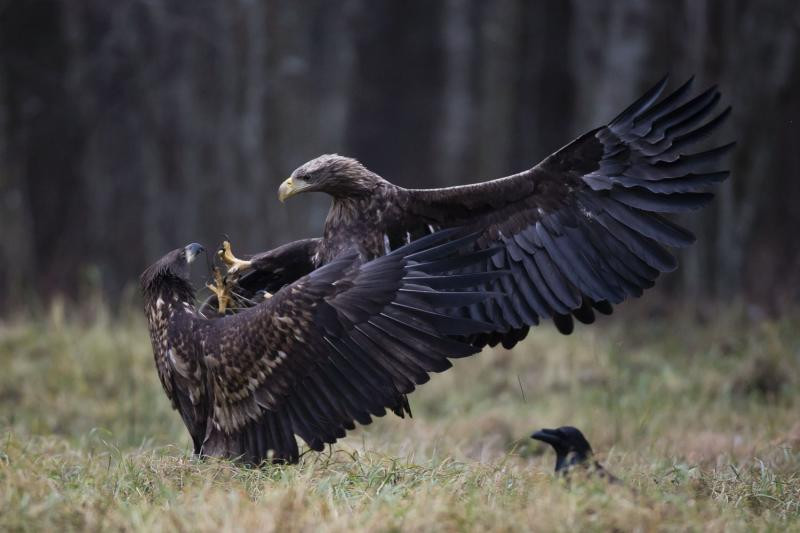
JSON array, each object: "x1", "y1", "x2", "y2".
[{"x1": 140, "y1": 229, "x2": 507, "y2": 465}]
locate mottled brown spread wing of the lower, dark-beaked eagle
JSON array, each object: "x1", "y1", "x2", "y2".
[{"x1": 204, "y1": 231, "x2": 498, "y2": 463}]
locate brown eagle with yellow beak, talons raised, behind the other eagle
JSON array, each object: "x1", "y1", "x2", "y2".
[{"x1": 217, "y1": 77, "x2": 735, "y2": 348}]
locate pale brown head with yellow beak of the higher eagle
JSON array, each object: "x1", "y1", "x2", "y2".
[{"x1": 278, "y1": 154, "x2": 381, "y2": 202}]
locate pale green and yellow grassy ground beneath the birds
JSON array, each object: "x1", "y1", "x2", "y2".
[{"x1": 0, "y1": 308, "x2": 800, "y2": 531}]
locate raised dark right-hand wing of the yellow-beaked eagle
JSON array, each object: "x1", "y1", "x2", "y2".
[{"x1": 399, "y1": 78, "x2": 733, "y2": 346}]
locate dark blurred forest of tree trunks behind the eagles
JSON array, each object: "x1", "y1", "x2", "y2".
[{"x1": 0, "y1": 0, "x2": 800, "y2": 310}]
